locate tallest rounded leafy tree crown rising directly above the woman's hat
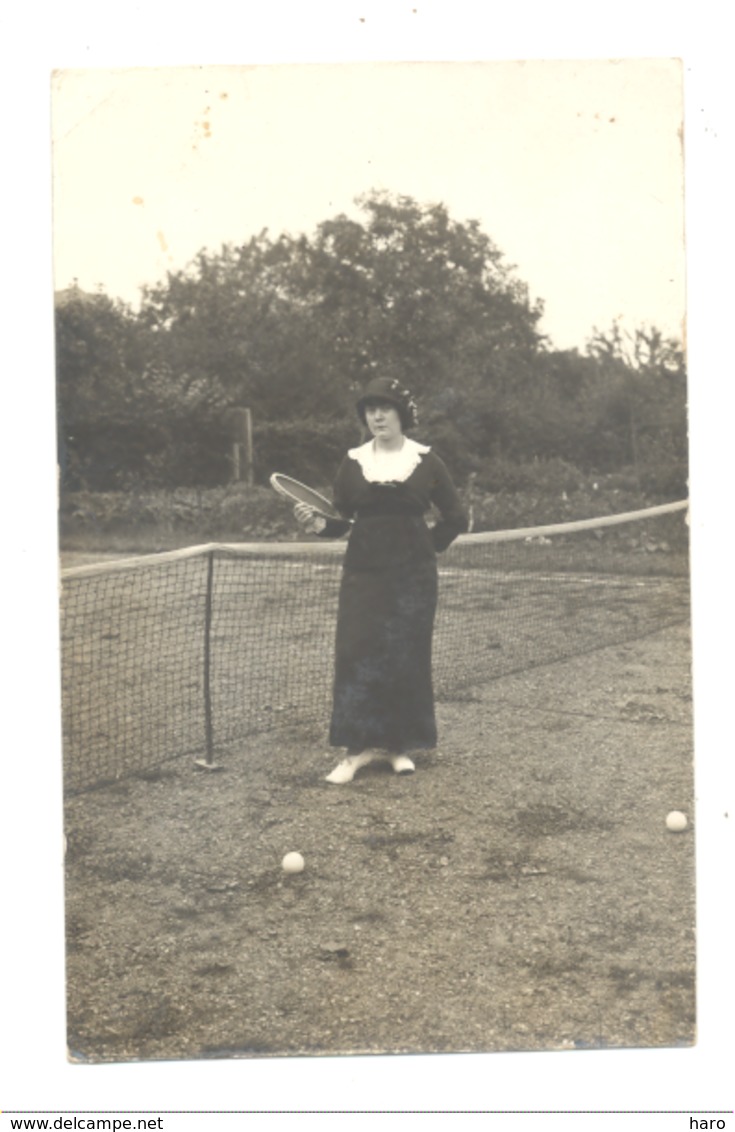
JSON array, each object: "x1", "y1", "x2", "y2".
[{"x1": 294, "y1": 192, "x2": 541, "y2": 404}]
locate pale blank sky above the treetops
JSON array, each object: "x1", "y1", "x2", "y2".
[{"x1": 53, "y1": 59, "x2": 684, "y2": 349}]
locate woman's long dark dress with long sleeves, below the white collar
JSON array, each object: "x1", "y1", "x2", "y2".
[{"x1": 324, "y1": 439, "x2": 467, "y2": 753}]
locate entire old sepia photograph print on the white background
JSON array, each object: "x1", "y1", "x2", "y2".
[{"x1": 52, "y1": 58, "x2": 696, "y2": 1065}]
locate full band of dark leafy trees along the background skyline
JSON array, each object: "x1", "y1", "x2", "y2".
[{"x1": 57, "y1": 192, "x2": 686, "y2": 487}]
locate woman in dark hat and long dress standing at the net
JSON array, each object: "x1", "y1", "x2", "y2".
[{"x1": 294, "y1": 378, "x2": 467, "y2": 784}]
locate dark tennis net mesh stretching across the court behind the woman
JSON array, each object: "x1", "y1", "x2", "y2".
[{"x1": 61, "y1": 504, "x2": 689, "y2": 792}]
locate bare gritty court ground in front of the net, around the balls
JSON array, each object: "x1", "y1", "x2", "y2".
[{"x1": 66, "y1": 626, "x2": 695, "y2": 1062}]
